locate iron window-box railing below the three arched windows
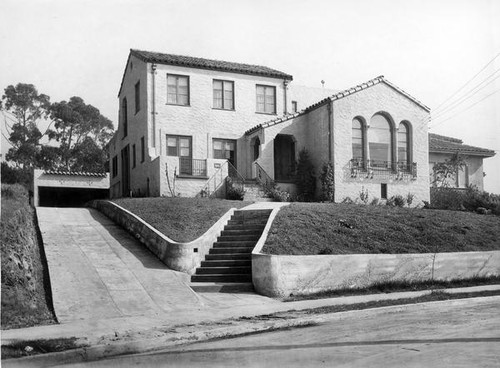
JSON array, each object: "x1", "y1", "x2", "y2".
[{"x1": 349, "y1": 158, "x2": 417, "y2": 180}]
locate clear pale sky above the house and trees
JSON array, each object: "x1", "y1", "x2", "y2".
[{"x1": 0, "y1": 0, "x2": 500, "y2": 194}]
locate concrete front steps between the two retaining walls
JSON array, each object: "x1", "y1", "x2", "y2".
[{"x1": 191, "y1": 210, "x2": 271, "y2": 292}]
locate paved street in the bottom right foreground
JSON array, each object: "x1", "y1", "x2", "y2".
[{"x1": 53, "y1": 296, "x2": 500, "y2": 368}]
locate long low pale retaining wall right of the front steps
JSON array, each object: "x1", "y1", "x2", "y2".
[{"x1": 252, "y1": 251, "x2": 500, "y2": 297}]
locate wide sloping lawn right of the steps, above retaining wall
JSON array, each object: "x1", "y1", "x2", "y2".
[{"x1": 262, "y1": 203, "x2": 500, "y2": 255}]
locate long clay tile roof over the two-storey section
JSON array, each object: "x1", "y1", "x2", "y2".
[{"x1": 130, "y1": 49, "x2": 293, "y2": 80}]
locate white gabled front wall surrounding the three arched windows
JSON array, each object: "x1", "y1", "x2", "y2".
[{"x1": 333, "y1": 83, "x2": 429, "y2": 205}]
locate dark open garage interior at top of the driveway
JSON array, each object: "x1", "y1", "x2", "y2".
[{"x1": 38, "y1": 187, "x2": 109, "y2": 207}]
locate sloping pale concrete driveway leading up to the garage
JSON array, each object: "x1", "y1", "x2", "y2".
[{"x1": 37, "y1": 207, "x2": 202, "y2": 323}]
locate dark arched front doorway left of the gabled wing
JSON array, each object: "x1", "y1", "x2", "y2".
[{"x1": 274, "y1": 134, "x2": 295, "y2": 182}]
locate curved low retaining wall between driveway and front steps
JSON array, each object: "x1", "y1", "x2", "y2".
[{"x1": 89, "y1": 200, "x2": 235, "y2": 275}]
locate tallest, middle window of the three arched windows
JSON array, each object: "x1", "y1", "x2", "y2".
[{"x1": 368, "y1": 114, "x2": 392, "y2": 168}]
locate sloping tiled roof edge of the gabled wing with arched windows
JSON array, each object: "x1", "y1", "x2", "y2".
[{"x1": 245, "y1": 75, "x2": 431, "y2": 135}]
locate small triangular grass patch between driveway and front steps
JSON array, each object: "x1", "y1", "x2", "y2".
[{"x1": 113, "y1": 197, "x2": 249, "y2": 242}]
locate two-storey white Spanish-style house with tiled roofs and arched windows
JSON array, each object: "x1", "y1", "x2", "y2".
[{"x1": 108, "y1": 50, "x2": 494, "y2": 203}]
